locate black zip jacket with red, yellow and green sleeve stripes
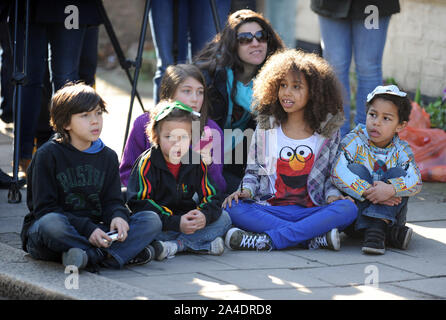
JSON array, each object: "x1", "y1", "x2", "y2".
[{"x1": 127, "y1": 147, "x2": 222, "y2": 232}]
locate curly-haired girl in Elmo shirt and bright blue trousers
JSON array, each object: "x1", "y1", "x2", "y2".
[{"x1": 223, "y1": 49, "x2": 357, "y2": 250}]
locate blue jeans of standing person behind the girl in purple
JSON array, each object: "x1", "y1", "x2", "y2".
[{"x1": 149, "y1": 0, "x2": 231, "y2": 103}]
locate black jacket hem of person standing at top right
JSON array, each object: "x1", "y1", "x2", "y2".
[{"x1": 311, "y1": 0, "x2": 400, "y2": 19}]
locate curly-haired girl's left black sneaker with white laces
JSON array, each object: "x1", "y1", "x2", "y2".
[{"x1": 225, "y1": 228, "x2": 273, "y2": 251}]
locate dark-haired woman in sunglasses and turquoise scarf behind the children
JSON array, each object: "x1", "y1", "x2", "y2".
[{"x1": 194, "y1": 9, "x2": 284, "y2": 194}]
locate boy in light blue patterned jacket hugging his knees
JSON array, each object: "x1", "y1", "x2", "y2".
[{"x1": 332, "y1": 85, "x2": 422, "y2": 254}]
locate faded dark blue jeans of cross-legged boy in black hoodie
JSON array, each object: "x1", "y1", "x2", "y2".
[{"x1": 27, "y1": 212, "x2": 161, "y2": 268}]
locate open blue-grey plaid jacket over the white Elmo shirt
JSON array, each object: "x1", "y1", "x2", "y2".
[{"x1": 241, "y1": 113, "x2": 344, "y2": 206}]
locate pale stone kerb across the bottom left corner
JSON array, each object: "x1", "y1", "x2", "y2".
[{"x1": 0, "y1": 243, "x2": 170, "y2": 300}]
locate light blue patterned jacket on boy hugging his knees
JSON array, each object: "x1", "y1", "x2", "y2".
[{"x1": 332, "y1": 124, "x2": 422, "y2": 201}]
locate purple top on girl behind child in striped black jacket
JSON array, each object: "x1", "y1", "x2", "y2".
[{"x1": 119, "y1": 113, "x2": 226, "y2": 193}]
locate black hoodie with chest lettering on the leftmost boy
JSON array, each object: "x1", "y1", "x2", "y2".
[{"x1": 21, "y1": 140, "x2": 129, "y2": 251}]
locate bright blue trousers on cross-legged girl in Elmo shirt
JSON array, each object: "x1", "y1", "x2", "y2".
[{"x1": 226, "y1": 200, "x2": 358, "y2": 249}]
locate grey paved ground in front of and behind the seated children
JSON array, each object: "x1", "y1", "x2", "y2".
[{"x1": 0, "y1": 67, "x2": 446, "y2": 300}]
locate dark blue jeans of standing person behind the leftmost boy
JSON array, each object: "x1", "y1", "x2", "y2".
[{"x1": 13, "y1": 24, "x2": 86, "y2": 159}]
